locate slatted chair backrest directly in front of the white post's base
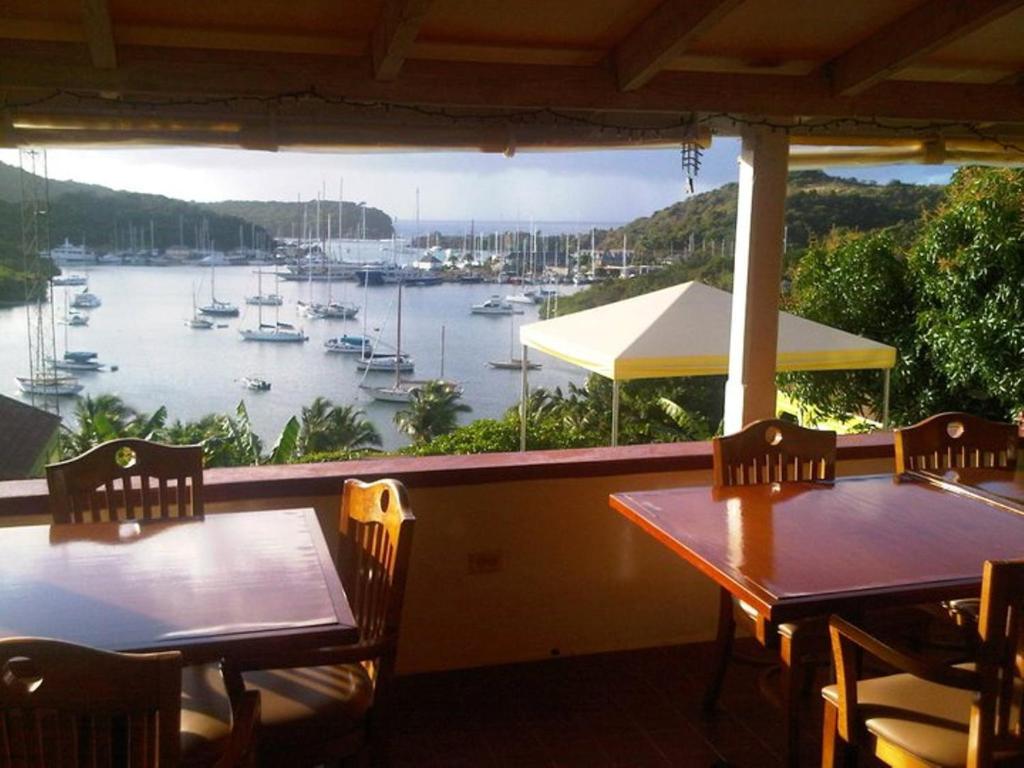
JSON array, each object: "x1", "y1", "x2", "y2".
[{"x1": 712, "y1": 419, "x2": 836, "y2": 487}]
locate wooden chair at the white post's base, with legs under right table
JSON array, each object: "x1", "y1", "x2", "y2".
[{"x1": 703, "y1": 419, "x2": 836, "y2": 757}]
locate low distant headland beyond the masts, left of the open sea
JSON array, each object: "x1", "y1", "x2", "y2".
[{"x1": 203, "y1": 200, "x2": 394, "y2": 240}]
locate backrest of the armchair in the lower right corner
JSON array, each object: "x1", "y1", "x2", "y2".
[{"x1": 968, "y1": 560, "x2": 1024, "y2": 768}]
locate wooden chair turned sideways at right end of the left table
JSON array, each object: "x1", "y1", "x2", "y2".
[{"x1": 239, "y1": 480, "x2": 415, "y2": 765}]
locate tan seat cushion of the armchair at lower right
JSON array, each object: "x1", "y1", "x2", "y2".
[{"x1": 821, "y1": 665, "x2": 974, "y2": 766}]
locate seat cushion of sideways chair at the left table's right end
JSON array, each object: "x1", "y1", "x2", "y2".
[{"x1": 243, "y1": 664, "x2": 374, "y2": 744}]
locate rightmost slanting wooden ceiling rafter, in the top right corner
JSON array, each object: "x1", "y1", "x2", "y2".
[{"x1": 825, "y1": 0, "x2": 1024, "y2": 96}]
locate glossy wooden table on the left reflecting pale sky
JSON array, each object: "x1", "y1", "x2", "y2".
[{"x1": 0, "y1": 509, "x2": 357, "y2": 664}]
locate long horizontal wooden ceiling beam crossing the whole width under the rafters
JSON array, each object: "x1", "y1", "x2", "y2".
[{"x1": 0, "y1": 47, "x2": 1024, "y2": 126}]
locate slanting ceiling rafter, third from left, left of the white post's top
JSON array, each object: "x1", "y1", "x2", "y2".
[{"x1": 611, "y1": 0, "x2": 743, "y2": 91}]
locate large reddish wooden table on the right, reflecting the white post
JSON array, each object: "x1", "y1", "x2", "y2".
[{"x1": 609, "y1": 475, "x2": 1024, "y2": 765}]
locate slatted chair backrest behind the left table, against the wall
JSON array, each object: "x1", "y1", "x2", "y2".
[{"x1": 46, "y1": 438, "x2": 203, "y2": 522}]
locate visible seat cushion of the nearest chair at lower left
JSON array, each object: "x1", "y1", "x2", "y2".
[{"x1": 181, "y1": 664, "x2": 231, "y2": 766}]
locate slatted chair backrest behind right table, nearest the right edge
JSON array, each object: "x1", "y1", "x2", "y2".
[{"x1": 893, "y1": 412, "x2": 1019, "y2": 474}]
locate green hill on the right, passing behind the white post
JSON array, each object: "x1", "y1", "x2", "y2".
[{"x1": 602, "y1": 171, "x2": 943, "y2": 255}]
